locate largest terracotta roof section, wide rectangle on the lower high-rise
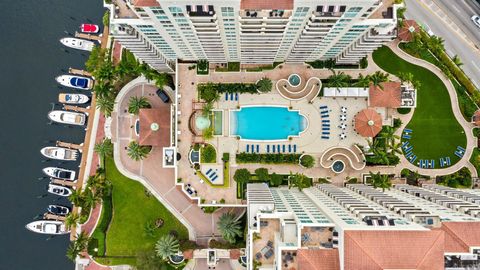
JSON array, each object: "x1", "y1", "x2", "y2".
[{"x1": 344, "y1": 230, "x2": 445, "y2": 270}]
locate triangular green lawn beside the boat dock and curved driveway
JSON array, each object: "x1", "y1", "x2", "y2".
[{"x1": 105, "y1": 158, "x2": 188, "y2": 256}]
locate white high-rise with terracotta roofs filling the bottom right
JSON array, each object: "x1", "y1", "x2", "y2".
[{"x1": 247, "y1": 184, "x2": 480, "y2": 270}]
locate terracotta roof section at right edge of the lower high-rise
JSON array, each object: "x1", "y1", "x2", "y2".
[{"x1": 441, "y1": 222, "x2": 480, "y2": 252}]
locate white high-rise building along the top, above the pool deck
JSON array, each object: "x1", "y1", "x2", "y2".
[{"x1": 109, "y1": 0, "x2": 397, "y2": 71}]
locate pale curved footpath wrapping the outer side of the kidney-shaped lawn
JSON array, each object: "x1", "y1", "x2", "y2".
[{"x1": 388, "y1": 40, "x2": 476, "y2": 175}]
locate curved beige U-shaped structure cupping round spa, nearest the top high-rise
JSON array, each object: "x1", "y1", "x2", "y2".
[{"x1": 275, "y1": 77, "x2": 322, "y2": 102}]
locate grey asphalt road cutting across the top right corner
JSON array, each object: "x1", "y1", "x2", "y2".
[{"x1": 405, "y1": 0, "x2": 480, "y2": 88}]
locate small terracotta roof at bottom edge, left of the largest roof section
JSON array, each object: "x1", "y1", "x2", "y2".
[{"x1": 297, "y1": 249, "x2": 340, "y2": 270}]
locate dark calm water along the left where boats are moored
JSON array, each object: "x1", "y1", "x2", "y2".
[{"x1": 0, "y1": 0, "x2": 103, "y2": 270}]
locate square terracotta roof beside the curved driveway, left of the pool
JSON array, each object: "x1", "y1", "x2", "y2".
[{"x1": 138, "y1": 106, "x2": 170, "y2": 146}]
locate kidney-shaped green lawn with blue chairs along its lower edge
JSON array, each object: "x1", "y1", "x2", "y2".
[{"x1": 373, "y1": 46, "x2": 467, "y2": 168}]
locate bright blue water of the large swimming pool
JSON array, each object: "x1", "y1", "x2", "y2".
[{"x1": 230, "y1": 106, "x2": 307, "y2": 140}]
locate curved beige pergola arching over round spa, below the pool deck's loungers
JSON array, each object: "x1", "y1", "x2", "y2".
[{"x1": 320, "y1": 145, "x2": 366, "y2": 171}]
